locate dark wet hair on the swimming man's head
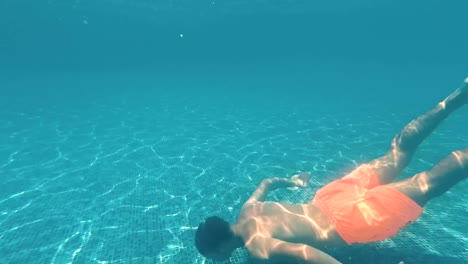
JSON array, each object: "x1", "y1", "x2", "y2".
[{"x1": 195, "y1": 216, "x2": 234, "y2": 255}]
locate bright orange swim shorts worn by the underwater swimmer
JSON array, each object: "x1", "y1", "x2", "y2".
[{"x1": 313, "y1": 165, "x2": 423, "y2": 244}]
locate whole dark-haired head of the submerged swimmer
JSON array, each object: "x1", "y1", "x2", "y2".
[{"x1": 195, "y1": 216, "x2": 234, "y2": 260}]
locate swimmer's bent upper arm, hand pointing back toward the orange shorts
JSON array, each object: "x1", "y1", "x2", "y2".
[{"x1": 246, "y1": 173, "x2": 310, "y2": 204}]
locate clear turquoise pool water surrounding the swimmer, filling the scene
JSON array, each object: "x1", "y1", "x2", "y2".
[{"x1": 0, "y1": 0, "x2": 468, "y2": 264}]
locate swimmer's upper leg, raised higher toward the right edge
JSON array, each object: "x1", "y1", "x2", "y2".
[{"x1": 369, "y1": 78, "x2": 468, "y2": 184}]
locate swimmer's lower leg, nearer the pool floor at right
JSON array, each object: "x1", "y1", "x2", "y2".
[{"x1": 388, "y1": 148, "x2": 468, "y2": 206}]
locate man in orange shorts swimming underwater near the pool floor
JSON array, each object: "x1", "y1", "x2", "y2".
[{"x1": 195, "y1": 78, "x2": 468, "y2": 263}]
